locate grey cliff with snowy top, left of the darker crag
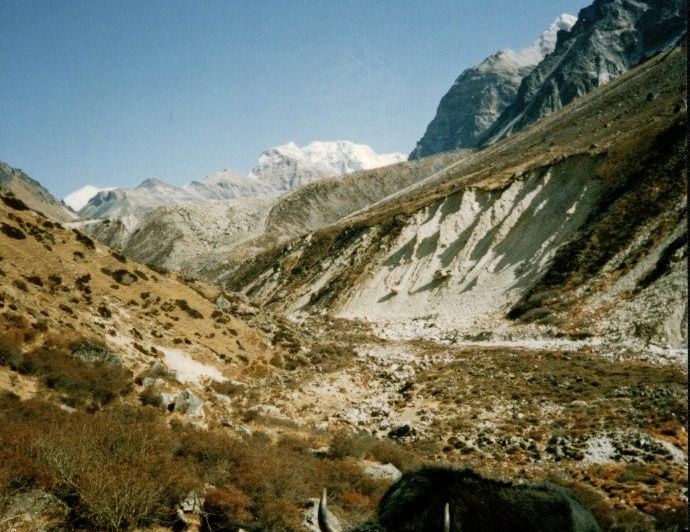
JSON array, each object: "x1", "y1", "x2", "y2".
[{"x1": 410, "y1": 14, "x2": 577, "y2": 159}]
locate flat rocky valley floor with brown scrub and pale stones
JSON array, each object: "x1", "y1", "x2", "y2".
[{"x1": 239, "y1": 318, "x2": 688, "y2": 530}]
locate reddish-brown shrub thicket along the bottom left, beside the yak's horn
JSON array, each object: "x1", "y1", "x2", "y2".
[{"x1": 0, "y1": 395, "x2": 386, "y2": 530}]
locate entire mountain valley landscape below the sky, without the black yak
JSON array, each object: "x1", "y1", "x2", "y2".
[{"x1": 0, "y1": 0, "x2": 688, "y2": 532}]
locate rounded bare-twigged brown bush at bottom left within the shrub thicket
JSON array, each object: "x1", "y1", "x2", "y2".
[{"x1": 37, "y1": 407, "x2": 196, "y2": 530}]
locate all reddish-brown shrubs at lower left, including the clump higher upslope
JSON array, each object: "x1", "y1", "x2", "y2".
[{"x1": 0, "y1": 335, "x2": 398, "y2": 530}]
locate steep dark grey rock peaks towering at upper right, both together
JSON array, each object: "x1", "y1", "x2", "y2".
[{"x1": 410, "y1": 0, "x2": 687, "y2": 159}]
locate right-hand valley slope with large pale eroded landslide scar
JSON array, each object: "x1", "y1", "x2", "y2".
[{"x1": 227, "y1": 41, "x2": 687, "y2": 347}]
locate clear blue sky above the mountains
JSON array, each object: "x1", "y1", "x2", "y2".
[{"x1": 0, "y1": 0, "x2": 589, "y2": 197}]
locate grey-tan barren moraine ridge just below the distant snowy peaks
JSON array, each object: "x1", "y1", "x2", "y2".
[{"x1": 78, "y1": 151, "x2": 467, "y2": 276}]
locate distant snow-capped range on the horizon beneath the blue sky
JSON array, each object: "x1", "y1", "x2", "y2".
[{"x1": 65, "y1": 140, "x2": 405, "y2": 218}]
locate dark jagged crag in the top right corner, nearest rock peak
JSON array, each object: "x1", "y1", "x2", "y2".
[{"x1": 481, "y1": 0, "x2": 687, "y2": 144}]
